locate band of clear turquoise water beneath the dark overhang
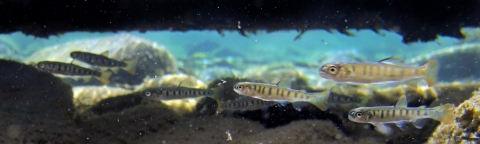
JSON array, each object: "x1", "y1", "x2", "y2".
[{"x1": 0, "y1": 30, "x2": 457, "y2": 63}]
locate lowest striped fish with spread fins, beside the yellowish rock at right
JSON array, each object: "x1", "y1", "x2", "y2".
[{"x1": 348, "y1": 95, "x2": 455, "y2": 135}]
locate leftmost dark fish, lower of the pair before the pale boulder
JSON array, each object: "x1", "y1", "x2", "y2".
[{"x1": 36, "y1": 61, "x2": 112, "y2": 84}]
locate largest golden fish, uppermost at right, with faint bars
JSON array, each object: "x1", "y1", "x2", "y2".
[{"x1": 319, "y1": 57, "x2": 439, "y2": 87}]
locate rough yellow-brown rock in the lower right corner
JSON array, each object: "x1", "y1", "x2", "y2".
[{"x1": 428, "y1": 89, "x2": 480, "y2": 144}]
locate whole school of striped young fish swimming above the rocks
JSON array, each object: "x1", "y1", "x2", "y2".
[{"x1": 36, "y1": 51, "x2": 455, "y2": 135}]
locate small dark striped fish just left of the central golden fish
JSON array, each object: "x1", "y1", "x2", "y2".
[{"x1": 142, "y1": 87, "x2": 214, "y2": 101}]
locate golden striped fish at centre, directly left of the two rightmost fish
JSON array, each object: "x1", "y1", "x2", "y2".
[{"x1": 233, "y1": 82, "x2": 328, "y2": 111}]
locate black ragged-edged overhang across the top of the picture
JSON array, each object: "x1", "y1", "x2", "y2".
[{"x1": 0, "y1": 0, "x2": 480, "y2": 42}]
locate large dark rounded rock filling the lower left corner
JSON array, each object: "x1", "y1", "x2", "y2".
[{"x1": 0, "y1": 60, "x2": 82, "y2": 143}]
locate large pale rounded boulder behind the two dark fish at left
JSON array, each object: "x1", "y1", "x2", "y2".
[{"x1": 25, "y1": 34, "x2": 177, "y2": 85}]
